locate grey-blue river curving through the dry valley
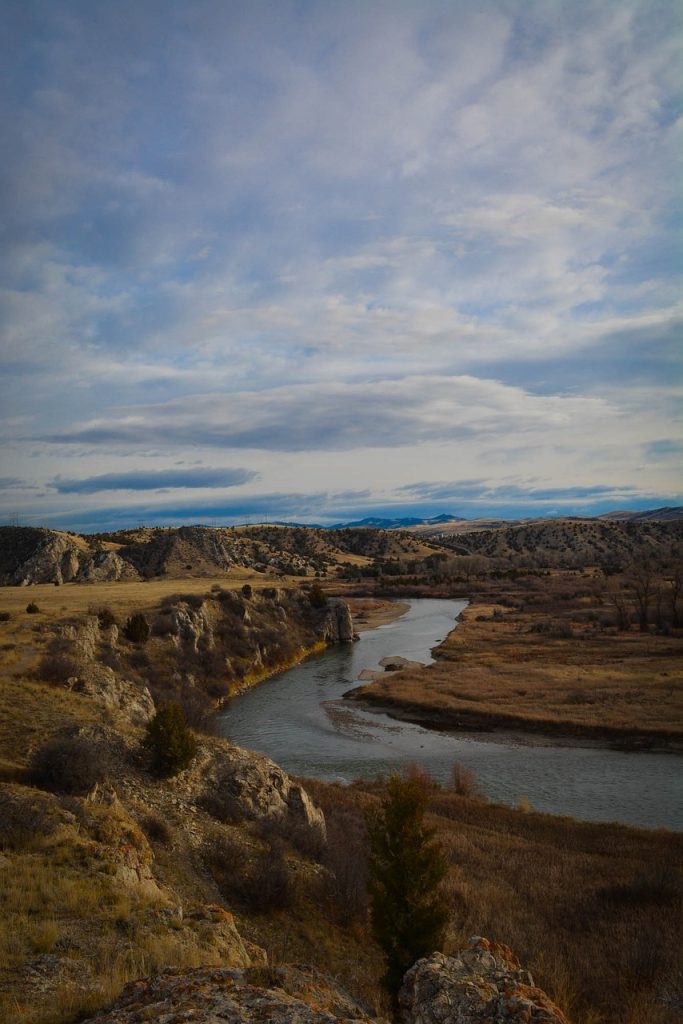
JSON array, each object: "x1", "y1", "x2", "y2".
[{"x1": 221, "y1": 598, "x2": 683, "y2": 830}]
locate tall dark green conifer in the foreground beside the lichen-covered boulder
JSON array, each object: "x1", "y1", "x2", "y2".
[{"x1": 368, "y1": 775, "x2": 449, "y2": 1011}]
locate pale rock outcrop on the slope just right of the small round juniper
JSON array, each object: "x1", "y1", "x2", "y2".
[{"x1": 175, "y1": 738, "x2": 325, "y2": 836}]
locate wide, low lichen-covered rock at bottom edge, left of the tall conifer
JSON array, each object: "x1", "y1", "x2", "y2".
[{"x1": 80, "y1": 968, "x2": 382, "y2": 1024}]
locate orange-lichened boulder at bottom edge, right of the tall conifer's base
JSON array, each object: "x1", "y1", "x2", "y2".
[{"x1": 398, "y1": 937, "x2": 568, "y2": 1024}]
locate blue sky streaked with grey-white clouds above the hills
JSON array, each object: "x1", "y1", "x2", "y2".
[{"x1": 0, "y1": 0, "x2": 683, "y2": 530}]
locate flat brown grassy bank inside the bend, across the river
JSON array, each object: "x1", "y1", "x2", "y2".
[{"x1": 346, "y1": 575, "x2": 683, "y2": 753}]
